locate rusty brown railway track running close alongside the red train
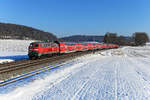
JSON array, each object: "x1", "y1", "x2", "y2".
[{"x1": 0, "y1": 51, "x2": 91, "y2": 74}]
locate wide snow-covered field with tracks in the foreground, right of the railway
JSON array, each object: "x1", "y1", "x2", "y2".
[{"x1": 0, "y1": 47, "x2": 150, "y2": 100}]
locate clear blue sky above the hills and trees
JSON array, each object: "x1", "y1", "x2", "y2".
[{"x1": 0, "y1": 0, "x2": 150, "y2": 37}]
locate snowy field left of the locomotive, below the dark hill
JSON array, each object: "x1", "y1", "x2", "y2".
[{"x1": 0, "y1": 40, "x2": 33, "y2": 63}]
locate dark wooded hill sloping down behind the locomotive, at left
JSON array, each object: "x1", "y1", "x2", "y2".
[{"x1": 0, "y1": 23, "x2": 57, "y2": 41}]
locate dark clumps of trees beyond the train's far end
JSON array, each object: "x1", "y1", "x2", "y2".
[{"x1": 104, "y1": 32, "x2": 149, "y2": 46}]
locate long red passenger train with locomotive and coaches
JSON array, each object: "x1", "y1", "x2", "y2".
[{"x1": 28, "y1": 42, "x2": 118, "y2": 59}]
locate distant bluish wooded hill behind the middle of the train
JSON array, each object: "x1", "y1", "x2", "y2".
[{"x1": 60, "y1": 35, "x2": 104, "y2": 42}]
